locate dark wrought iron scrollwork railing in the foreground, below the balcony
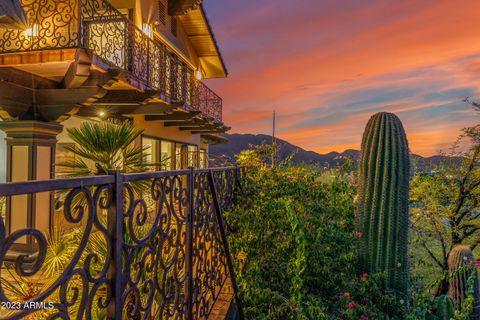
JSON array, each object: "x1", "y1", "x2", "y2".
[{"x1": 0, "y1": 167, "x2": 242, "y2": 319}]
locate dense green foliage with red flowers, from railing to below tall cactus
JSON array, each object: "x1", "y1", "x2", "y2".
[{"x1": 230, "y1": 146, "x2": 480, "y2": 320}]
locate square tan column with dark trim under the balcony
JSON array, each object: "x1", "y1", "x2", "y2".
[{"x1": 0, "y1": 120, "x2": 63, "y2": 248}]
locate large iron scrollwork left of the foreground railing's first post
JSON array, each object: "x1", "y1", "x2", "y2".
[{"x1": 0, "y1": 185, "x2": 113, "y2": 319}]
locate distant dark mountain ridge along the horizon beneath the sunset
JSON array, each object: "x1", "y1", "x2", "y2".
[{"x1": 210, "y1": 133, "x2": 454, "y2": 167}]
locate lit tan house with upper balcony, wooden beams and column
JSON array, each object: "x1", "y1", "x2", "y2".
[{"x1": 0, "y1": 0, "x2": 229, "y2": 240}]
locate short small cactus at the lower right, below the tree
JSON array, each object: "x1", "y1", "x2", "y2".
[{"x1": 448, "y1": 245, "x2": 480, "y2": 319}]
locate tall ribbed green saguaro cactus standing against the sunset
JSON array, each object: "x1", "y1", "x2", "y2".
[{"x1": 357, "y1": 112, "x2": 410, "y2": 292}]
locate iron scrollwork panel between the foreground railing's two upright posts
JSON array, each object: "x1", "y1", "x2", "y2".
[{"x1": 122, "y1": 176, "x2": 188, "y2": 319}]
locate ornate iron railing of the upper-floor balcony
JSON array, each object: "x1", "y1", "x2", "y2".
[{"x1": 0, "y1": 0, "x2": 222, "y2": 121}]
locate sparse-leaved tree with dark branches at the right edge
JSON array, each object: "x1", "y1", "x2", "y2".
[{"x1": 410, "y1": 125, "x2": 480, "y2": 295}]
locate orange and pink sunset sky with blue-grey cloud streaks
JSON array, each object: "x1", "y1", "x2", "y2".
[{"x1": 204, "y1": 0, "x2": 480, "y2": 155}]
